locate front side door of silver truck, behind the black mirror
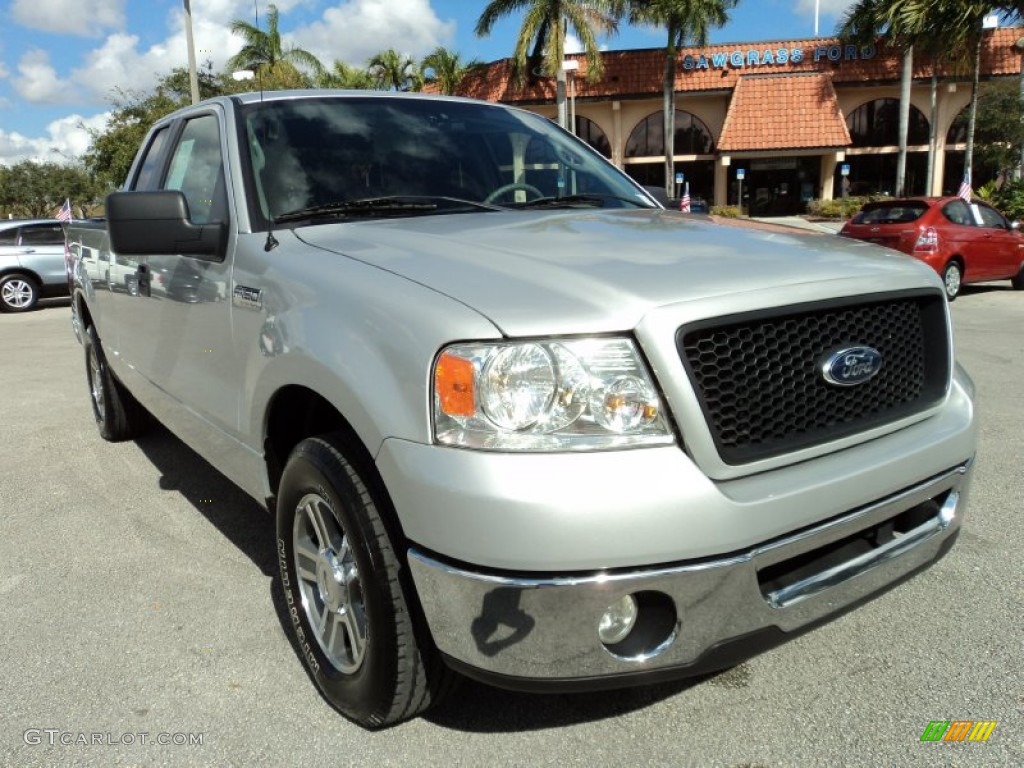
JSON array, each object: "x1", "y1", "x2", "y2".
[{"x1": 126, "y1": 111, "x2": 241, "y2": 453}]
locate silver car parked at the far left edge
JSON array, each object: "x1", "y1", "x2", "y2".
[{"x1": 0, "y1": 219, "x2": 68, "y2": 312}]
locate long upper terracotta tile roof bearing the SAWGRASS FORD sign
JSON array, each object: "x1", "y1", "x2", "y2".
[{"x1": 461, "y1": 28, "x2": 1021, "y2": 103}]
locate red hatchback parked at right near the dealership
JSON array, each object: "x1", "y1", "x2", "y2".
[{"x1": 840, "y1": 198, "x2": 1024, "y2": 301}]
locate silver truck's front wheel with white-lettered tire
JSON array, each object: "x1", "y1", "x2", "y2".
[{"x1": 278, "y1": 435, "x2": 454, "y2": 728}]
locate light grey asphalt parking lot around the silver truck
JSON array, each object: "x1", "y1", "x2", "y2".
[{"x1": 0, "y1": 284, "x2": 1024, "y2": 768}]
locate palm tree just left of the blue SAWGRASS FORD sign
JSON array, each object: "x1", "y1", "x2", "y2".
[{"x1": 630, "y1": 0, "x2": 739, "y2": 198}]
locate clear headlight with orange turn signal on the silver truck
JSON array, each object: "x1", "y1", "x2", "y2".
[{"x1": 433, "y1": 338, "x2": 675, "y2": 451}]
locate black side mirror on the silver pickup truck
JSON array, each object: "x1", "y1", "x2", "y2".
[{"x1": 106, "y1": 189, "x2": 227, "y2": 259}]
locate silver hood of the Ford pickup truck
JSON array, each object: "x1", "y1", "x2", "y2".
[{"x1": 294, "y1": 210, "x2": 934, "y2": 335}]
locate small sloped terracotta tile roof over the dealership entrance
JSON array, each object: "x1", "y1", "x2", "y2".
[{"x1": 718, "y1": 73, "x2": 850, "y2": 152}]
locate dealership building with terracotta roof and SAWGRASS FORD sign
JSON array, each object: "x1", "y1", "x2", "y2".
[{"x1": 461, "y1": 28, "x2": 1024, "y2": 215}]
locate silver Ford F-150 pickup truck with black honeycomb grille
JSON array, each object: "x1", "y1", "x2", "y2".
[{"x1": 68, "y1": 91, "x2": 976, "y2": 727}]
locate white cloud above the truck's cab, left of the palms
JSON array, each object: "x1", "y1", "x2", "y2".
[{"x1": 296, "y1": 0, "x2": 455, "y2": 68}]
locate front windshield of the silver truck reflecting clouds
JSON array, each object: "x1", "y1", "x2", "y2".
[{"x1": 243, "y1": 96, "x2": 655, "y2": 221}]
